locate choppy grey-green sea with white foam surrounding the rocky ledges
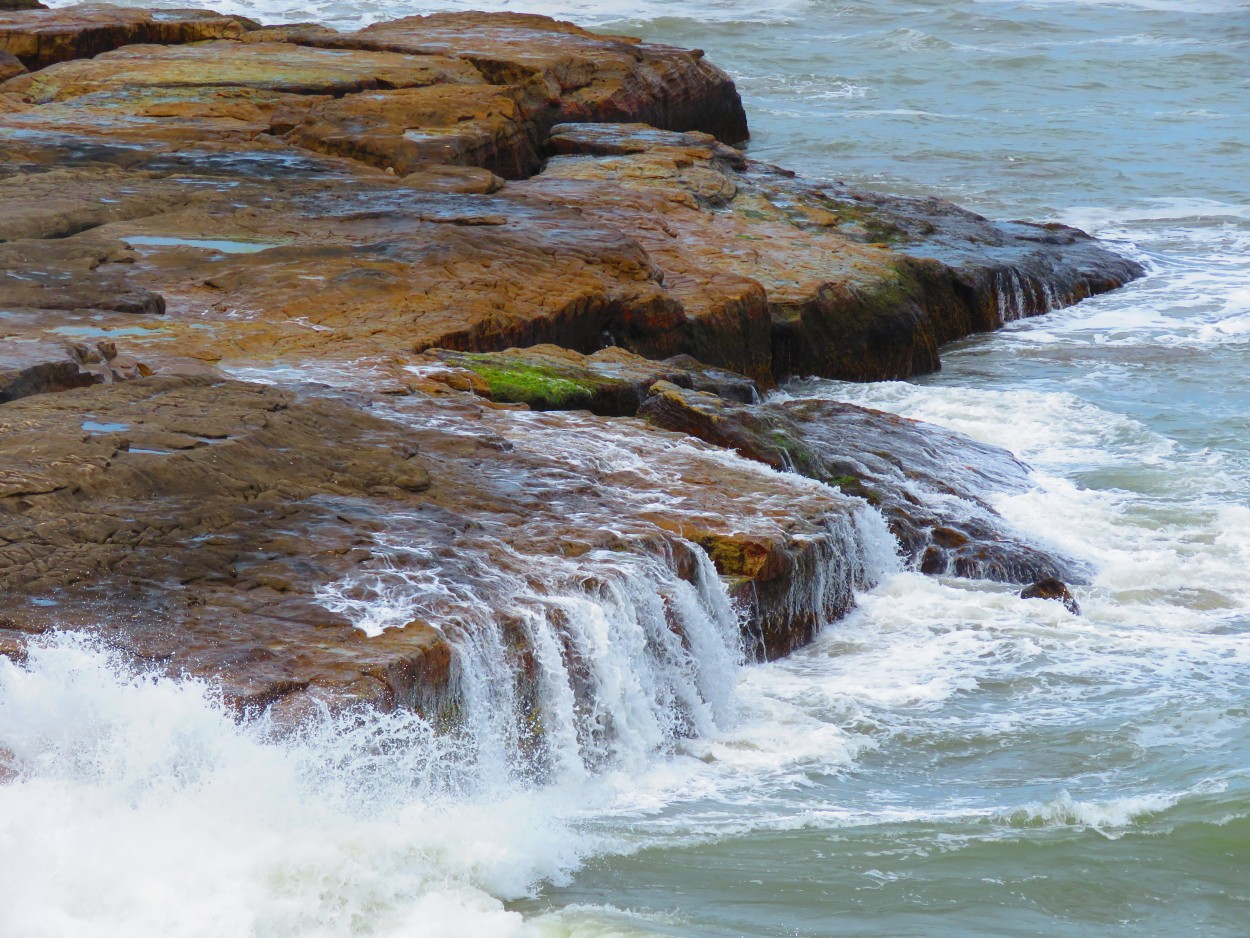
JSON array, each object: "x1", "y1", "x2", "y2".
[{"x1": 9, "y1": 0, "x2": 1250, "y2": 938}]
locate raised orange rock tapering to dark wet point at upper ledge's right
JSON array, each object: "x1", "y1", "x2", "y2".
[{"x1": 520, "y1": 125, "x2": 1141, "y2": 380}]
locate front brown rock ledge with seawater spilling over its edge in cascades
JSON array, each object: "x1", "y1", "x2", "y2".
[{"x1": 0, "y1": 378, "x2": 880, "y2": 714}]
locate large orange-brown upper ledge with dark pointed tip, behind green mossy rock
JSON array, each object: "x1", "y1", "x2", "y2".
[{"x1": 0, "y1": 10, "x2": 1135, "y2": 386}]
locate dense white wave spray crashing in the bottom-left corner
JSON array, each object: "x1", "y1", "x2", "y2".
[{"x1": 0, "y1": 637, "x2": 579, "y2": 938}]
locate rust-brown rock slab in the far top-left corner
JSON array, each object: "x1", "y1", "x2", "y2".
[{"x1": 0, "y1": 4, "x2": 254, "y2": 69}]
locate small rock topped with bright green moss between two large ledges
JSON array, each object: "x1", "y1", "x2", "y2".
[{"x1": 414, "y1": 345, "x2": 759, "y2": 416}]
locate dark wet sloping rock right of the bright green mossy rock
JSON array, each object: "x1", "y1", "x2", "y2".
[{"x1": 639, "y1": 384, "x2": 1084, "y2": 583}]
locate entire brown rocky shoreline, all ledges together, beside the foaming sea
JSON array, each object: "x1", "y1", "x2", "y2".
[{"x1": 0, "y1": 4, "x2": 1141, "y2": 720}]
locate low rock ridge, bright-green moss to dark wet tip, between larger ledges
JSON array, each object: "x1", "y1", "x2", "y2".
[{"x1": 414, "y1": 346, "x2": 1086, "y2": 595}]
